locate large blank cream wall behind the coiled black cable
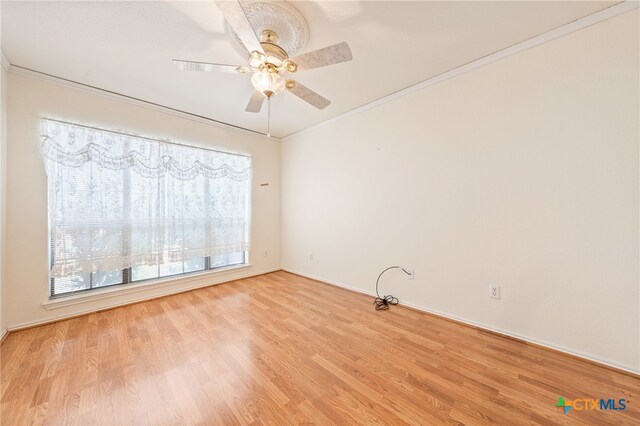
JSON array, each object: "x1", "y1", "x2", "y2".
[{"x1": 282, "y1": 10, "x2": 640, "y2": 371}]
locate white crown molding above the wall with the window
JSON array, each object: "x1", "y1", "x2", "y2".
[{"x1": 7, "y1": 64, "x2": 280, "y2": 141}]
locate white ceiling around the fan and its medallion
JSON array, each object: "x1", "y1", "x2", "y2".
[{"x1": 2, "y1": 1, "x2": 617, "y2": 137}]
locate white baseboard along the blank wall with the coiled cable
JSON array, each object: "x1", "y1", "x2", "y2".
[{"x1": 282, "y1": 267, "x2": 640, "y2": 374}]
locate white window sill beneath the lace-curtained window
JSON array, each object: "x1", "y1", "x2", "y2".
[{"x1": 42, "y1": 263, "x2": 251, "y2": 310}]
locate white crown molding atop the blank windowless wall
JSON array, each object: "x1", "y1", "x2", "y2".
[{"x1": 280, "y1": 0, "x2": 640, "y2": 142}]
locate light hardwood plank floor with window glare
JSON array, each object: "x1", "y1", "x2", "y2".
[{"x1": 0, "y1": 272, "x2": 640, "y2": 425}]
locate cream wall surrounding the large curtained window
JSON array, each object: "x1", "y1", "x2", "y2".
[{"x1": 4, "y1": 71, "x2": 281, "y2": 329}]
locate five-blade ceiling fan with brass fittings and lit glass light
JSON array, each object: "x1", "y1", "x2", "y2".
[{"x1": 173, "y1": 1, "x2": 352, "y2": 123}]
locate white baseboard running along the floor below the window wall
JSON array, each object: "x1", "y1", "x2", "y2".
[{"x1": 5, "y1": 268, "x2": 281, "y2": 333}]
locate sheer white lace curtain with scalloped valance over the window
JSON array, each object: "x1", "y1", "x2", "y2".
[{"x1": 42, "y1": 120, "x2": 251, "y2": 278}]
